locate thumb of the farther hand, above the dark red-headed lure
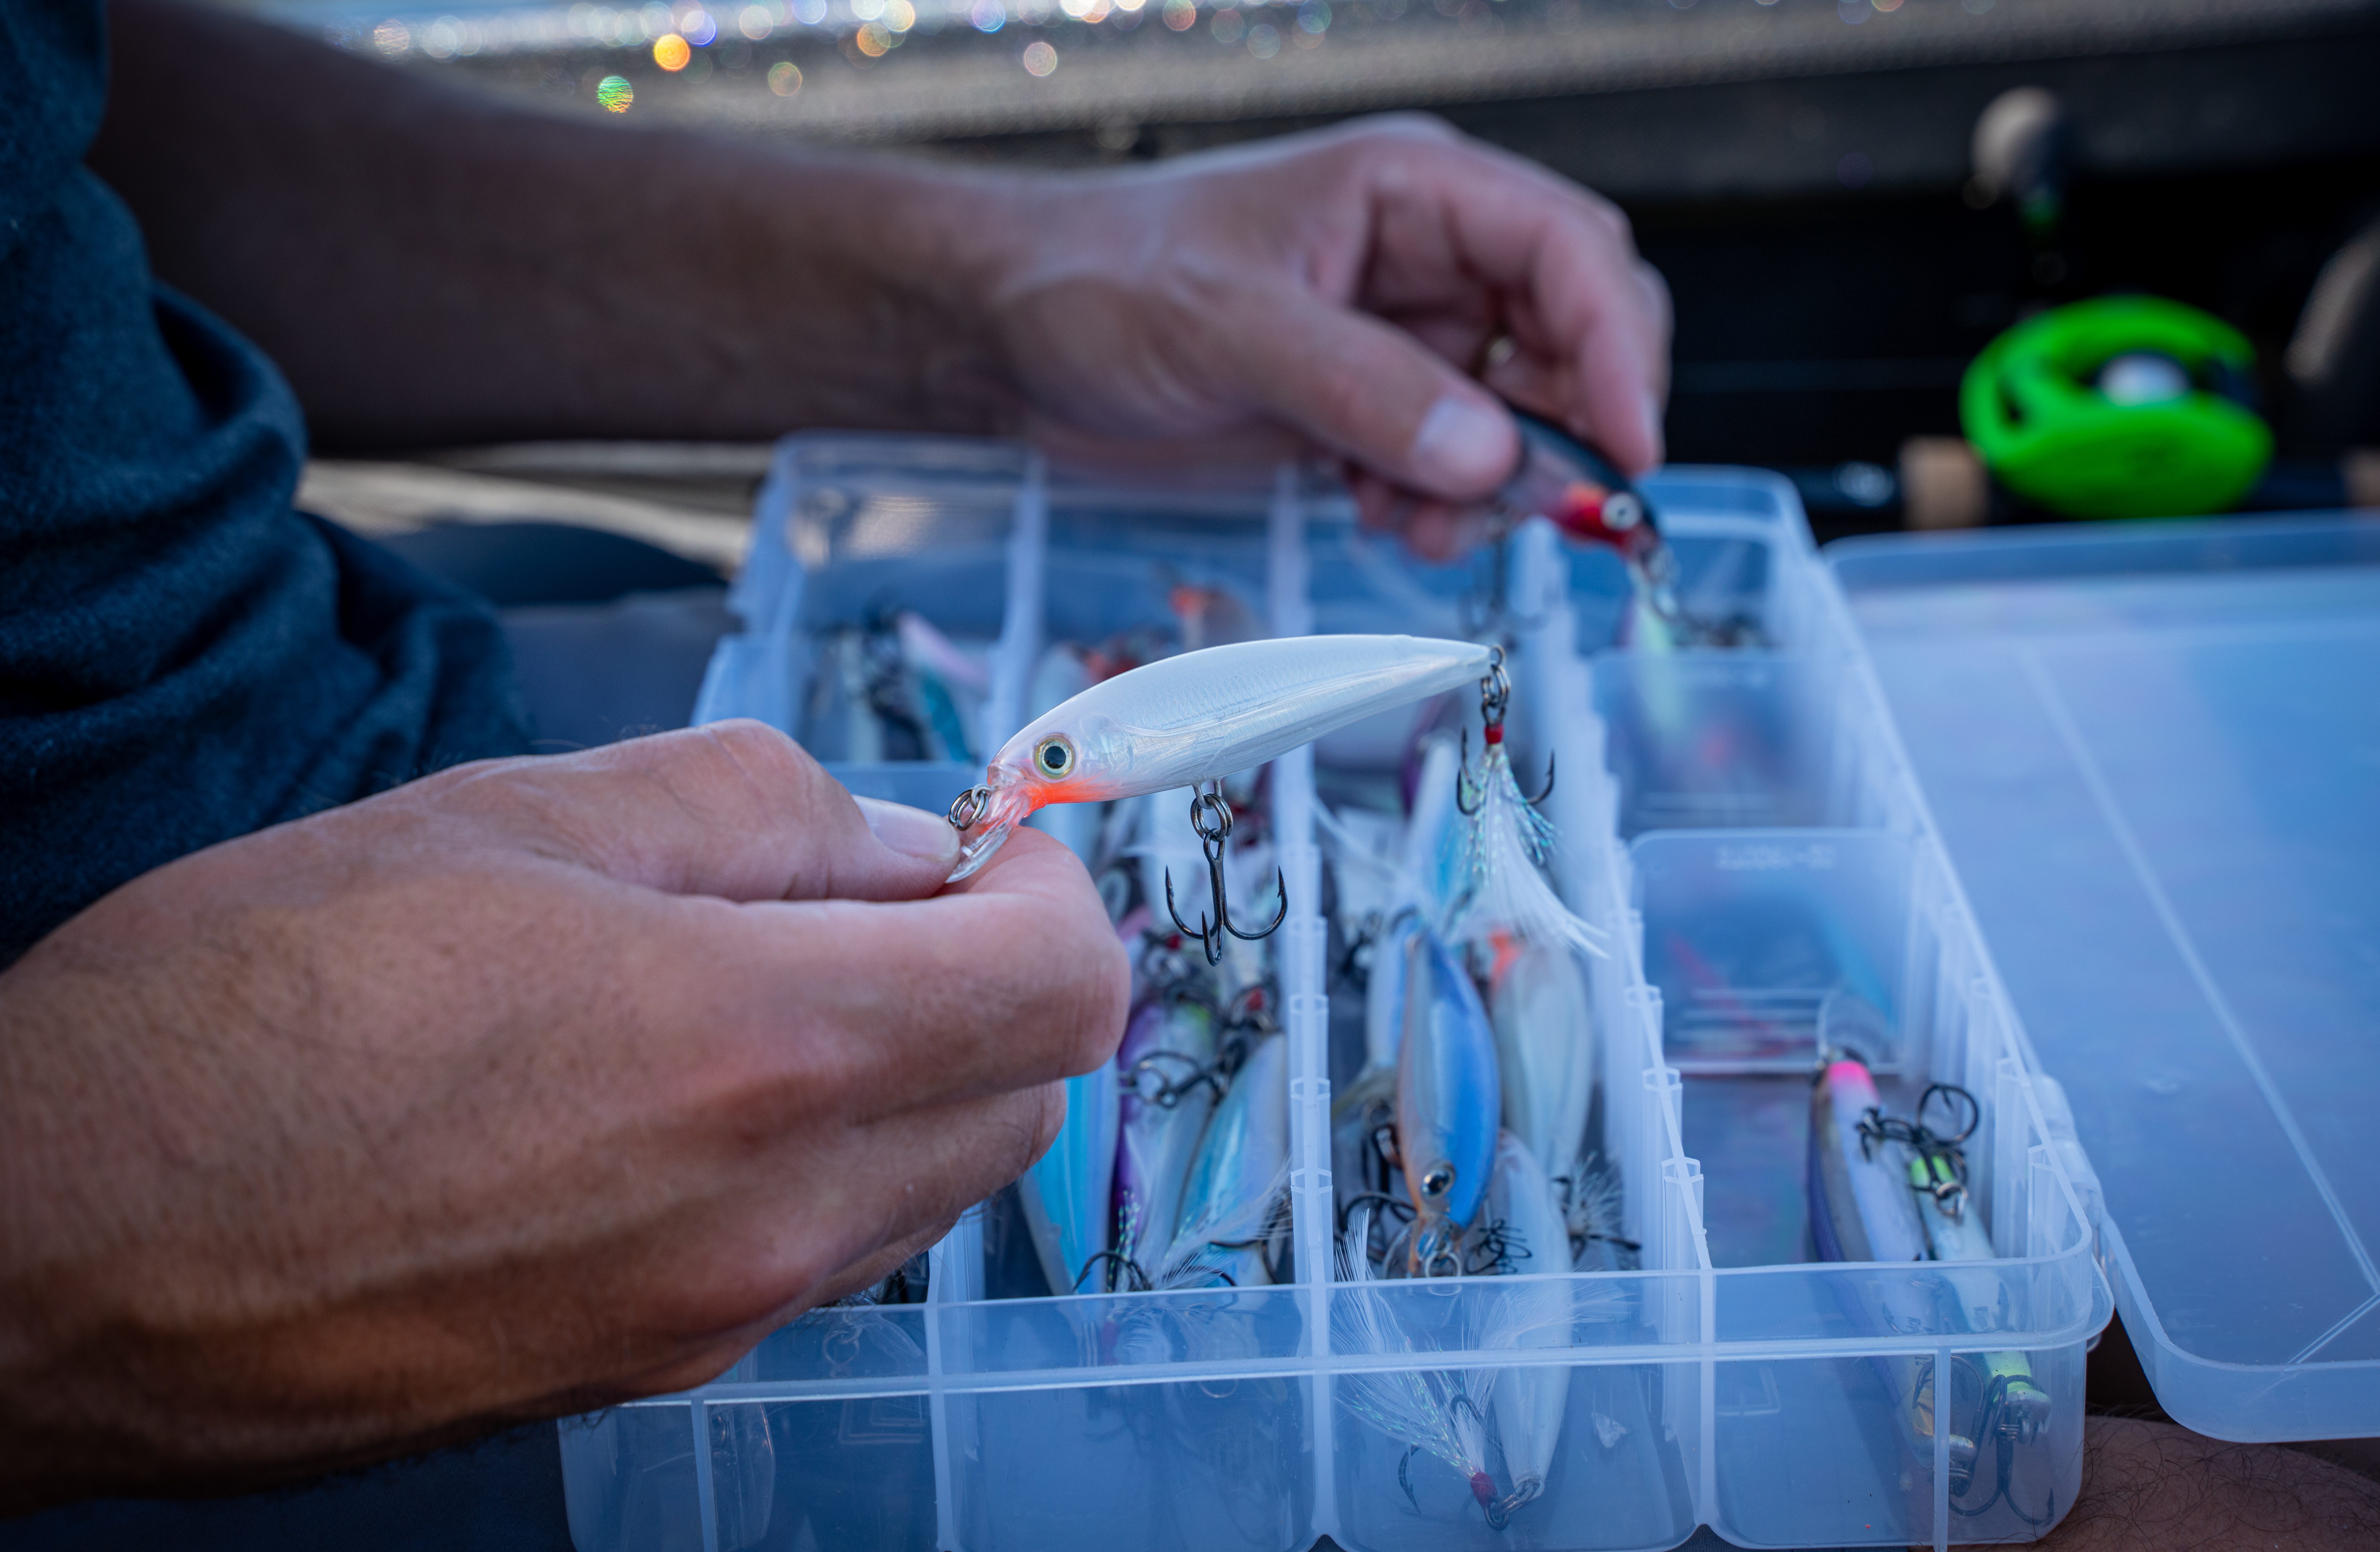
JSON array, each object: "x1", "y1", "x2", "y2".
[{"x1": 1228, "y1": 291, "x2": 1521, "y2": 502}]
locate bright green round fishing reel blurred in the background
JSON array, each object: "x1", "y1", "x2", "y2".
[{"x1": 1959, "y1": 297, "x2": 2273, "y2": 516}]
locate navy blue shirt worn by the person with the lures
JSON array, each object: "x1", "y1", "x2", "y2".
[{"x1": 0, "y1": 0, "x2": 528, "y2": 967}]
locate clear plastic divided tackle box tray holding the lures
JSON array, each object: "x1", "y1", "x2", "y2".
[{"x1": 562, "y1": 436, "x2": 2137, "y2": 1552}]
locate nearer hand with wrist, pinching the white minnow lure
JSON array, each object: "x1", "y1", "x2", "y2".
[{"x1": 0, "y1": 724, "x2": 1128, "y2": 1509}]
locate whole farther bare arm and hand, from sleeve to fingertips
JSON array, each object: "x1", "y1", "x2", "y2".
[{"x1": 90, "y1": 0, "x2": 1668, "y2": 555}]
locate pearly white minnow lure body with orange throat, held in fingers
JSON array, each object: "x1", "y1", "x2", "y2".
[{"x1": 950, "y1": 635, "x2": 1495, "y2": 883}]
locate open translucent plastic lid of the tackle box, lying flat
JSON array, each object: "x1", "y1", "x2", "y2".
[{"x1": 1826, "y1": 512, "x2": 2380, "y2": 1440}]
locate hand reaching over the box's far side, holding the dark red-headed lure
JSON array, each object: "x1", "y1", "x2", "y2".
[{"x1": 988, "y1": 119, "x2": 1668, "y2": 555}]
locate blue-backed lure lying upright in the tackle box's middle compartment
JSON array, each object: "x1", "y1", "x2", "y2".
[{"x1": 1397, "y1": 933, "x2": 1502, "y2": 1276}]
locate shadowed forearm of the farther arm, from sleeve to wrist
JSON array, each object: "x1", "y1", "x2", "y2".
[{"x1": 90, "y1": 0, "x2": 1033, "y2": 448}]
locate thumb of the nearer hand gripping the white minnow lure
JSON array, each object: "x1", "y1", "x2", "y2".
[{"x1": 442, "y1": 721, "x2": 959, "y2": 900}]
